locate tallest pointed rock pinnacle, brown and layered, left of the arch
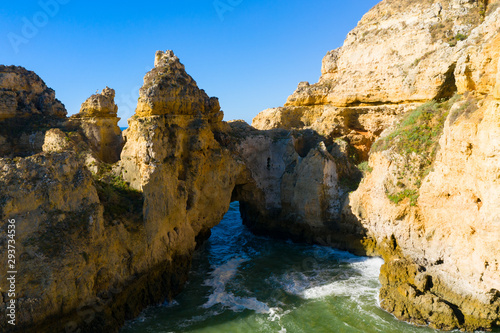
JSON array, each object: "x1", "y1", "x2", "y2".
[{"x1": 120, "y1": 51, "x2": 242, "y2": 274}]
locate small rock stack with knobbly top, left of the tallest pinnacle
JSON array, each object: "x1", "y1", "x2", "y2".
[{"x1": 70, "y1": 87, "x2": 123, "y2": 163}]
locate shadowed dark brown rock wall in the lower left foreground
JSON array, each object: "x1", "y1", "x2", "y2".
[{"x1": 0, "y1": 152, "x2": 103, "y2": 329}]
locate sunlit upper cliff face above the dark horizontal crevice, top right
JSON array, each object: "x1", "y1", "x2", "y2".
[{"x1": 285, "y1": 0, "x2": 490, "y2": 106}]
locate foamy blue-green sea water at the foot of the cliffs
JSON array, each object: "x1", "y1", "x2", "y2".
[{"x1": 117, "y1": 203, "x2": 484, "y2": 333}]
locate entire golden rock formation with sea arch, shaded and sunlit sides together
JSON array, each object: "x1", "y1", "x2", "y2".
[{"x1": 0, "y1": 0, "x2": 500, "y2": 332}]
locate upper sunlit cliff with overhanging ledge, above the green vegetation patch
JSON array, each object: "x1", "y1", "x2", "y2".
[{"x1": 252, "y1": 0, "x2": 496, "y2": 162}]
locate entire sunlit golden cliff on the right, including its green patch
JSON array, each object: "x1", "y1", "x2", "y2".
[{"x1": 252, "y1": 1, "x2": 500, "y2": 330}]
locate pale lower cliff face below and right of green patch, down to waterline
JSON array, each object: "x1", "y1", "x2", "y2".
[{"x1": 346, "y1": 94, "x2": 500, "y2": 329}]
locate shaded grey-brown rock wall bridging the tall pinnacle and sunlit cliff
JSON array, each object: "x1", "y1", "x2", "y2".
[{"x1": 230, "y1": 121, "x2": 362, "y2": 248}]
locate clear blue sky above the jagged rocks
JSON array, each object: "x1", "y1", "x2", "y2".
[{"x1": 0, "y1": 0, "x2": 378, "y2": 126}]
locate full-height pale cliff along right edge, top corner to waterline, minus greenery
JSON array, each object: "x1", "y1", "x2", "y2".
[{"x1": 338, "y1": 7, "x2": 500, "y2": 330}]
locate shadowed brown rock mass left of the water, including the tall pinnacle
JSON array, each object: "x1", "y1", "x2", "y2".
[{"x1": 0, "y1": 52, "x2": 242, "y2": 332}]
